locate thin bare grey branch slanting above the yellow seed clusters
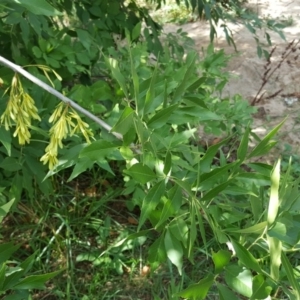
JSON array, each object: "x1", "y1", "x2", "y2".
[{"x1": 0, "y1": 56, "x2": 123, "y2": 140}]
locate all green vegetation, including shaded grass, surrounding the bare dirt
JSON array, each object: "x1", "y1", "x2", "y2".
[{"x1": 0, "y1": 0, "x2": 300, "y2": 299}]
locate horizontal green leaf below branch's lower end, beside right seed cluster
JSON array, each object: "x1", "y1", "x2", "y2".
[{"x1": 79, "y1": 140, "x2": 119, "y2": 160}]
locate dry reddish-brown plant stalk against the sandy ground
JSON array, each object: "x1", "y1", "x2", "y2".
[{"x1": 251, "y1": 40, "x2": 300, "y2": 106}]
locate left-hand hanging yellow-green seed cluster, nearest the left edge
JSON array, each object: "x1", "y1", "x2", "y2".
[{"x1": 0, "y1": 75, "x2": 41, "y2": 145}]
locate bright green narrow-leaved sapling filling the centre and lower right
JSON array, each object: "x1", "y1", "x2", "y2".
[{"x1": 68, "y1": 38, "x2": 296, "y2": 299}]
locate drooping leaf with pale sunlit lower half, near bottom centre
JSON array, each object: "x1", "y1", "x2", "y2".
[{"x1": 164, "y1": 230, "x2": 183, "y2": 275}]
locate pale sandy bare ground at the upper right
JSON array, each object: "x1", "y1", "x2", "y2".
[{"x1": 164, "y1": 0, "x2": 300, "y2": 153}]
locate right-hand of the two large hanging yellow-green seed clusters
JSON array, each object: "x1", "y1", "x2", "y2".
[{"x1": 41, "y1": 103, "x2": 93, "y2": 170}]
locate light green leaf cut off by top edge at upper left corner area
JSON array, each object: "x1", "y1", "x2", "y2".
[{"x1": 13, "y1": 0, "x2": 62, "y2": 17}]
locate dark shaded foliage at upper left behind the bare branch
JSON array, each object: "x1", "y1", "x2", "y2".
[{"x1": 0, "y1": 1, "x2": 193, "y2": 201}]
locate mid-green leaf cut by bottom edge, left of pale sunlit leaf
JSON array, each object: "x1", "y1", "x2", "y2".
[{"x1": 178, "y1": 274, "x2": 214, "y2": 300}]
